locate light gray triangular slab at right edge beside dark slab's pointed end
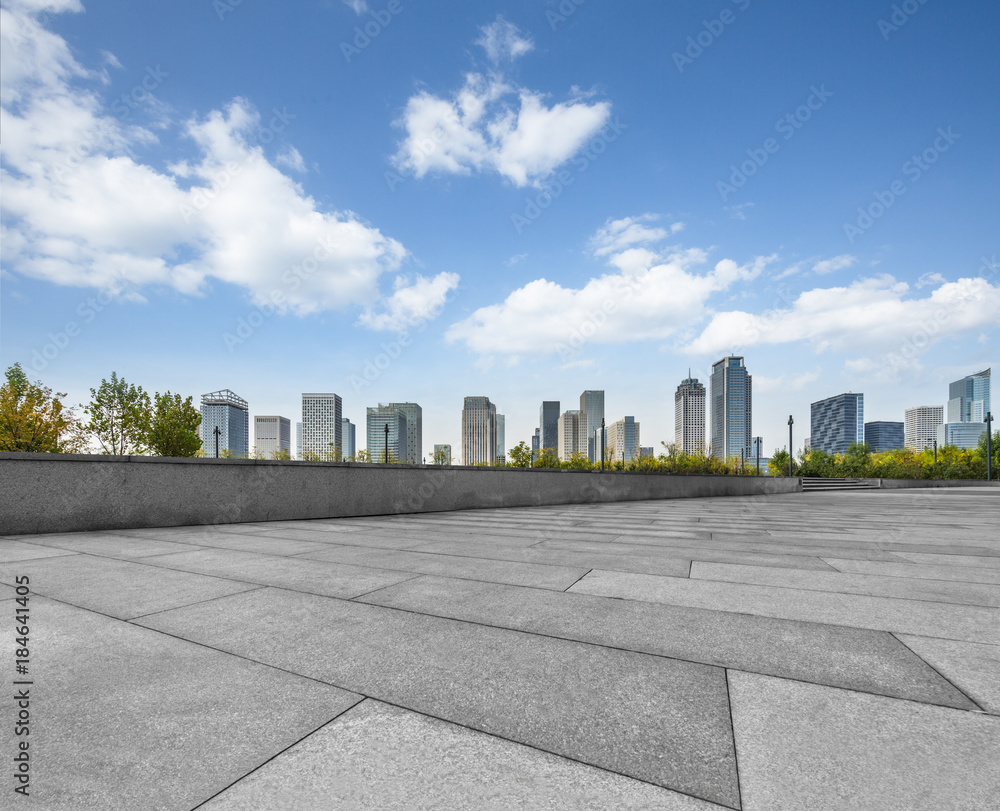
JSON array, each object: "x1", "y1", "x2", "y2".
[{"x1": 896, "y1": 634, "x2": 1000, "y2": 715}]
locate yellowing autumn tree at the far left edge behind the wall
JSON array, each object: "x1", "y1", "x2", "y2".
[{"x1": 0, "y1": 363, "x2": 85, "y2": 453}]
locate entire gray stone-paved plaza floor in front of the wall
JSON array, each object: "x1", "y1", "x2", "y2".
[{"x1": 0, "y1": 488, "x2": 1000, "y2": 811}]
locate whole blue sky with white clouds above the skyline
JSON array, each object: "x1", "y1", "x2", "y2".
[{"x1": 0, "y1": 0, "x2": 1000, "y2": 454}]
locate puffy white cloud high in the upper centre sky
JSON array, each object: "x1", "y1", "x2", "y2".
[{"x1": 393, "y1": 29, "x2": 611, "y2": 186}]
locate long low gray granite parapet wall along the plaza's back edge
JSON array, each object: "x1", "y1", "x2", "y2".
[{"x1": 0, "y1": 453, "x2": 801, "y2": 535}]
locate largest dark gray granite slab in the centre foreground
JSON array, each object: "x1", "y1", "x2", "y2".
[{"x1": 139, "y1": 589, "x2": 738, "y2": 807}]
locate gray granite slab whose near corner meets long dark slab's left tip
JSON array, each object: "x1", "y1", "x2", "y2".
[{"x1": 137, "y1": 549, "x2": 414, "y2": 598}]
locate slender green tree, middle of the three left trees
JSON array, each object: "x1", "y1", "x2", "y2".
[{"x1": 83, "y1": 372, "x2": 151, "y2": 456}]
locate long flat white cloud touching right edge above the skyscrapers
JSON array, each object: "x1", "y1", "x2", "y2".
[{"x1": 687, "y1": 275, "x2": 1000, "y2": 354}]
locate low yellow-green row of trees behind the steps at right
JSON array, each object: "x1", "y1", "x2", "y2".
[{"x1": 770, "y1": 444, "x2": 1000, "y2": 479}]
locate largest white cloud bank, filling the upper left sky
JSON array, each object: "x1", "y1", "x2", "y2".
[{"x1": 0, "y1": 3, "x2": 434, "y2": 326}]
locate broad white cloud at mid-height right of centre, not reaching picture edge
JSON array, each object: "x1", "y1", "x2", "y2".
[{"x1": 446, "y1": 224, "x2": 773, "y2": 357}]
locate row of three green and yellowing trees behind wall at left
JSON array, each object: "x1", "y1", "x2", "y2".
[{"x1": 0, "y1": 363, "x2": 201, "y2": 456}]
